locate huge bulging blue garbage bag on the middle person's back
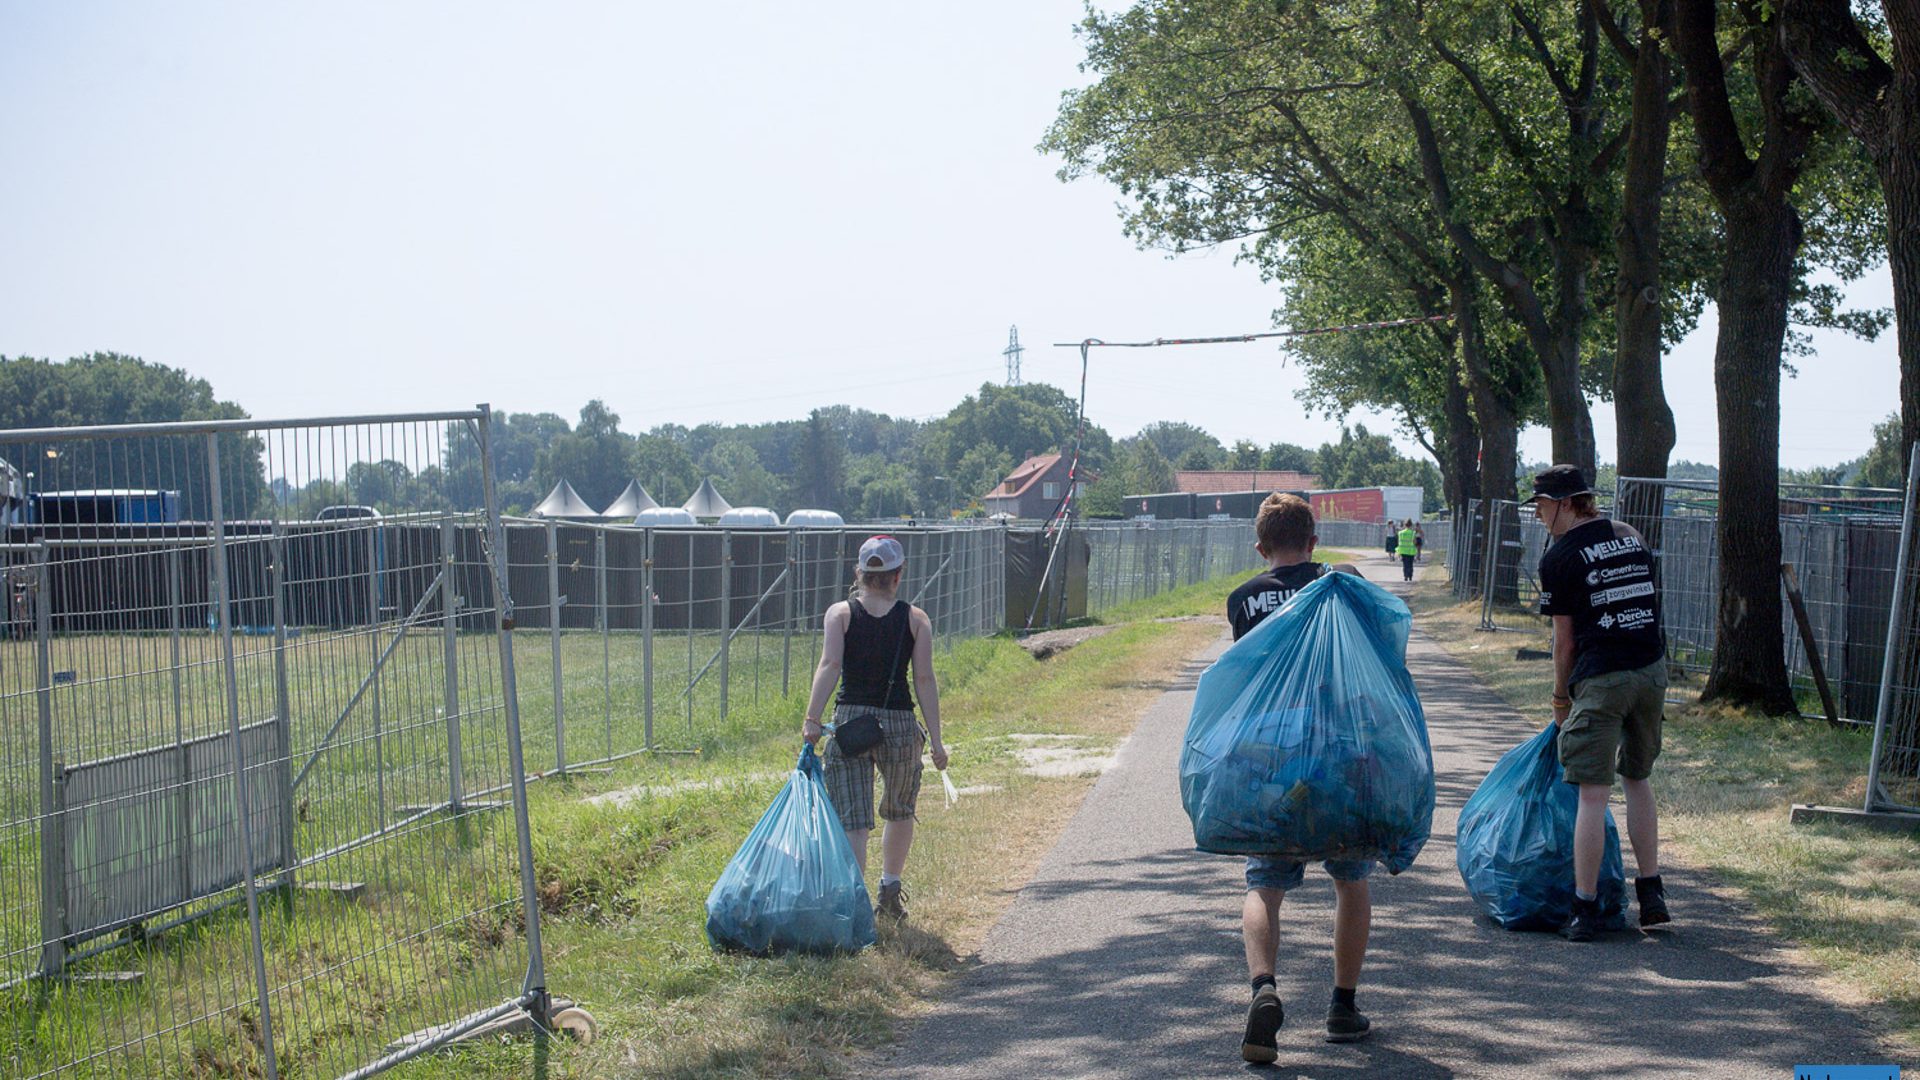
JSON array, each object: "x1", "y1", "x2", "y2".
[{"x1": 1181, "y1": 573, "x2": 1434, "y2": 874}]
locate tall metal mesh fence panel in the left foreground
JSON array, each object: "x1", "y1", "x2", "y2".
[{"x1": 0, "y1": 409, "x2": 545, "y2": 1076}]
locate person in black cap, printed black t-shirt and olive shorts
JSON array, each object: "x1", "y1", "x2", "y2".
[{"x1": 1534, "y1": 465, "x2": 1670, "y2": 942}]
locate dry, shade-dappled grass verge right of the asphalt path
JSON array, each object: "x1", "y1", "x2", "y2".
[{"x1": 1413, "y1": 580, "x2": 1920, "y2": 1051}]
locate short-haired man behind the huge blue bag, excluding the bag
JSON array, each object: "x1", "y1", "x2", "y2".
[{"x1": 1227, "y1": 494, "x2": 1373, "y2": 1063}]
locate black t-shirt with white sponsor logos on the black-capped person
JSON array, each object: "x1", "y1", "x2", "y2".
[{"x1": 1540, "y1": 517, "x2": 1667, "y2": 682}]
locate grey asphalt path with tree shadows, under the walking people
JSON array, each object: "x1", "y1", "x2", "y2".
[{"x1": 856, "y1": 557, "x2": 1887, "y2": 1080}]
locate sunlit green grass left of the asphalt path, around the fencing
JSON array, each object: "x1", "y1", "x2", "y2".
[{"x1": 0, "y1": 568, "x2": 1259, "y2": 1076}]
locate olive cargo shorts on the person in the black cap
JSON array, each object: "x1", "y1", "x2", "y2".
[{"x1": 1559, "y1": 657, "x2": 1667, "y2": 786}]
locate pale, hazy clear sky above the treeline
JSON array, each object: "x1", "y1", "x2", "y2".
[{"x1": 0, "y1": 0, "x2": 1897, "y2": 465}]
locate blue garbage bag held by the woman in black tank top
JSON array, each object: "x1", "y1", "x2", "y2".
[{"x1": 707, "y1": 744, "x2": 874, "y2": 955}]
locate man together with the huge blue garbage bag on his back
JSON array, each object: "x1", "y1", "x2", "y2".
[{"x1": 1181, "y1": 494, "x2": 1434, "y2": 1063}]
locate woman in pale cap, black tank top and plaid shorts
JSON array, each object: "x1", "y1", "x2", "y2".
[{"x1": 801, "y1": 536, "x2": 947, "y2": 919}]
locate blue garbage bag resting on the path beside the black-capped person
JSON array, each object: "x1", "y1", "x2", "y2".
[{"x1": 1455, "y1": 724, "x2": 1626, "y2": 930}]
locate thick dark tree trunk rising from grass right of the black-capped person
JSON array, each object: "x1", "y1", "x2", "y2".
[{"x1": 1701, "y1": 190, "x2": 1801, "y2": 713}]
